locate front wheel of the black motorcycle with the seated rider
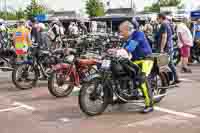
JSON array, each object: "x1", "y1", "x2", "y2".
[{"x1": 79, "y1": 79, "x2": 108, "y2": 116}]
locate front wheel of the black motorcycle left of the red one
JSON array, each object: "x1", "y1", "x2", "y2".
[{"x1": 12, "y1": 64, "x2": 39, "y2": 90}]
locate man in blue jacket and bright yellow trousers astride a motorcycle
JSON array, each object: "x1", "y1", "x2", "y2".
[{"x1": 119, "y1": 19, "x2": 153, "y2": 113}]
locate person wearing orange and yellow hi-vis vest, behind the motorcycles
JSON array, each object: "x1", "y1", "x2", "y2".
[{"x1": 13, "y1": 20, "x2": 31, "y2": 62}]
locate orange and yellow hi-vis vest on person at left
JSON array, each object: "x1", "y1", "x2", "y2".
[{"x1": 15, "y1": 27, "x2": 30, "y2": 55}]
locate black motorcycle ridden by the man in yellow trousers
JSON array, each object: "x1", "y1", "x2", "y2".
[{"x1": 79, "y1": 52, "x2": 168, "y2": 116}]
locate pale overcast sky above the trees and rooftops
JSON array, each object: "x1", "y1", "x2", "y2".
[{"x1": 0, "y1": 0, "x2": 200, "y2": 11}]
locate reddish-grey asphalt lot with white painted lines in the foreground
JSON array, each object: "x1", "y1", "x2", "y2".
[{"x1": 0, "y1": 66, "x2": 200, "y2": 133}]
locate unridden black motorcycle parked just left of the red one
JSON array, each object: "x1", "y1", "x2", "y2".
[{"x1": 12, "y1": 46, "x2": 64, "y2": 90}]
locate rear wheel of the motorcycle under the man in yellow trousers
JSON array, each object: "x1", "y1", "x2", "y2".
[{"x1": 150, "y1": 74, "x2": 168, "y2": 103}]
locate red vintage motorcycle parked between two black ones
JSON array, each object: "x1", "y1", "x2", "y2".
[{"x1": 48, "y1": 49, "x2": 98, "y2": 97}]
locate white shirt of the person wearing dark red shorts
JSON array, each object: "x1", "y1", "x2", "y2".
[{"x1": 177, "y1": 23, "x2": 193, "y2": 48}]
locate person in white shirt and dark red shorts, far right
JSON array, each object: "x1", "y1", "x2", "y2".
[{"x1": 177, "y1": 19, "x2": 193, "y2": 73}]
